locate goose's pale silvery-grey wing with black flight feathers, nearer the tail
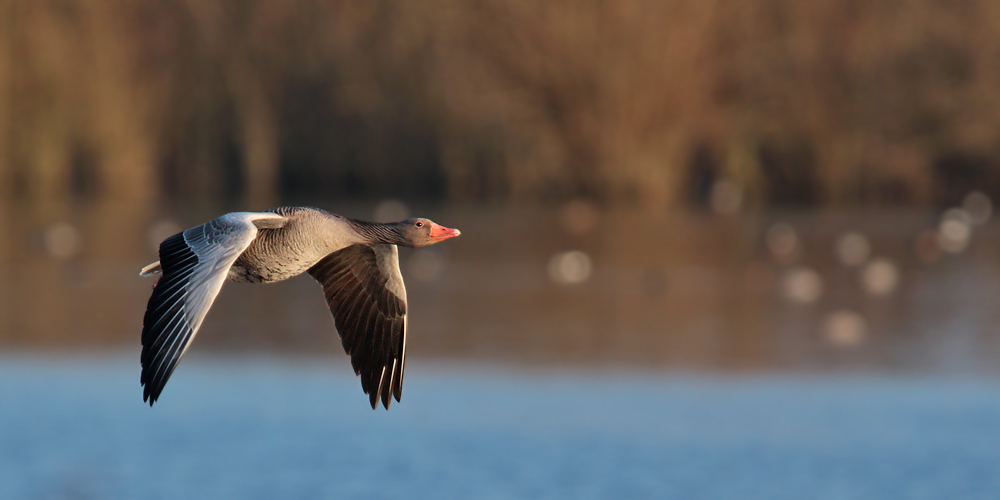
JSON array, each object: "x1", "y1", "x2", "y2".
[{"x1": 140, "y1": 212, "x2": 282, "y2": 406}]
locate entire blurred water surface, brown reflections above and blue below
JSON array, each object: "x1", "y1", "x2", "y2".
[{"x1": 0, "y1": 203, "x2": 1000, "y2": 500}]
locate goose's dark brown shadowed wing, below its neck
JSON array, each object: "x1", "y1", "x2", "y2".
[{"x1": 309, "y1": 244, "x2": 406, "y2": 409}]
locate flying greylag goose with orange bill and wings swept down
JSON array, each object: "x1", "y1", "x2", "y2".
[{"x1": 140, "y1": 207, "x2": 461, "y2": 409}]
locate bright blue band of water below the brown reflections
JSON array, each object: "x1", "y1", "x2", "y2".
[{"x1": 0, "y1": 357, "x2": 1000, "y2": 500}]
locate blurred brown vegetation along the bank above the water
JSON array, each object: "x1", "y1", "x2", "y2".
[{"x1": 0, "y1": 0, "x2": 1000, "y2": 207}]
